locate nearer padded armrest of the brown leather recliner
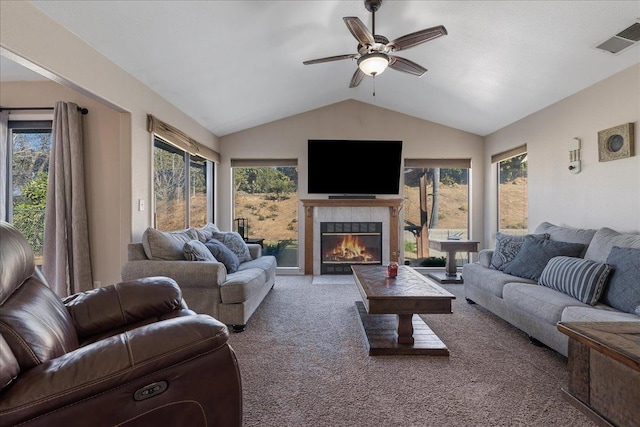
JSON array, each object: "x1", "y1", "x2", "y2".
[{"x1": 0, "y1": 315, "x2": 229, "y2": 425}]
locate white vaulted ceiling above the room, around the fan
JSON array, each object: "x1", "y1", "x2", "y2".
[{"x1": 2, "y1": 0, "x2": 640, "y2": 136}]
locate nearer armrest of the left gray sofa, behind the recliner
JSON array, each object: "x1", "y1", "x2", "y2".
[{"x1": 122, "y1": 260, "x2": 227, "y2": 289}]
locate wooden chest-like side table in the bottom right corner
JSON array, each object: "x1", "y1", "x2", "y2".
[{"x1": 557, "y1": 322, "x2": 640, "y2": 427}]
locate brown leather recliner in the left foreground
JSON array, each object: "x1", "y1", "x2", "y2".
[{"x1": 0, "y1": 222, "x2": 242, "y2": 427}]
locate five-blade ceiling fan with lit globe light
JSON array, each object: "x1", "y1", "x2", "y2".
[{"x1": 303, "y1": 0, "x2": 447, "y2": 88}]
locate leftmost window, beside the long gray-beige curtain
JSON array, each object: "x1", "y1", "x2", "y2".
[{"x1": 3, "y1": 121, "x2": 51, "y2": 265}]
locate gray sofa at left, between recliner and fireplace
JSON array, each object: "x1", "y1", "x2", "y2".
[{"x1": 122, "y1": 224, "x2": 277, "y2": 332}]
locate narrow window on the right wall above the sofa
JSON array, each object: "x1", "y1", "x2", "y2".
[{"x1": 491, "y1": 146, "x2": 528, "y2": 235}]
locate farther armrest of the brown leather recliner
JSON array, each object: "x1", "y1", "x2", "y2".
[{"x1": 63, "y1": 277, "x2": 183, "y2": 338}]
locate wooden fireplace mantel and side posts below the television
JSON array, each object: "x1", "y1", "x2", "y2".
[{"x1": 300, "y1": 199, "x2": 403, "y2": 274}]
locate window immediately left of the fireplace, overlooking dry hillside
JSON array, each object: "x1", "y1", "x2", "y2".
[{"x1": 231, "y1": 159, "x2": 299, "y2": 268}]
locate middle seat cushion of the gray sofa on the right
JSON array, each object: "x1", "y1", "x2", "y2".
[{"x1": 503, "y1": 283, "x2": 591, "y2": 325}]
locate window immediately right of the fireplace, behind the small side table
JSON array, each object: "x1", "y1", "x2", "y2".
[{"x1": 403, "y1": 159, "x2": 470, "y2": 267}]
